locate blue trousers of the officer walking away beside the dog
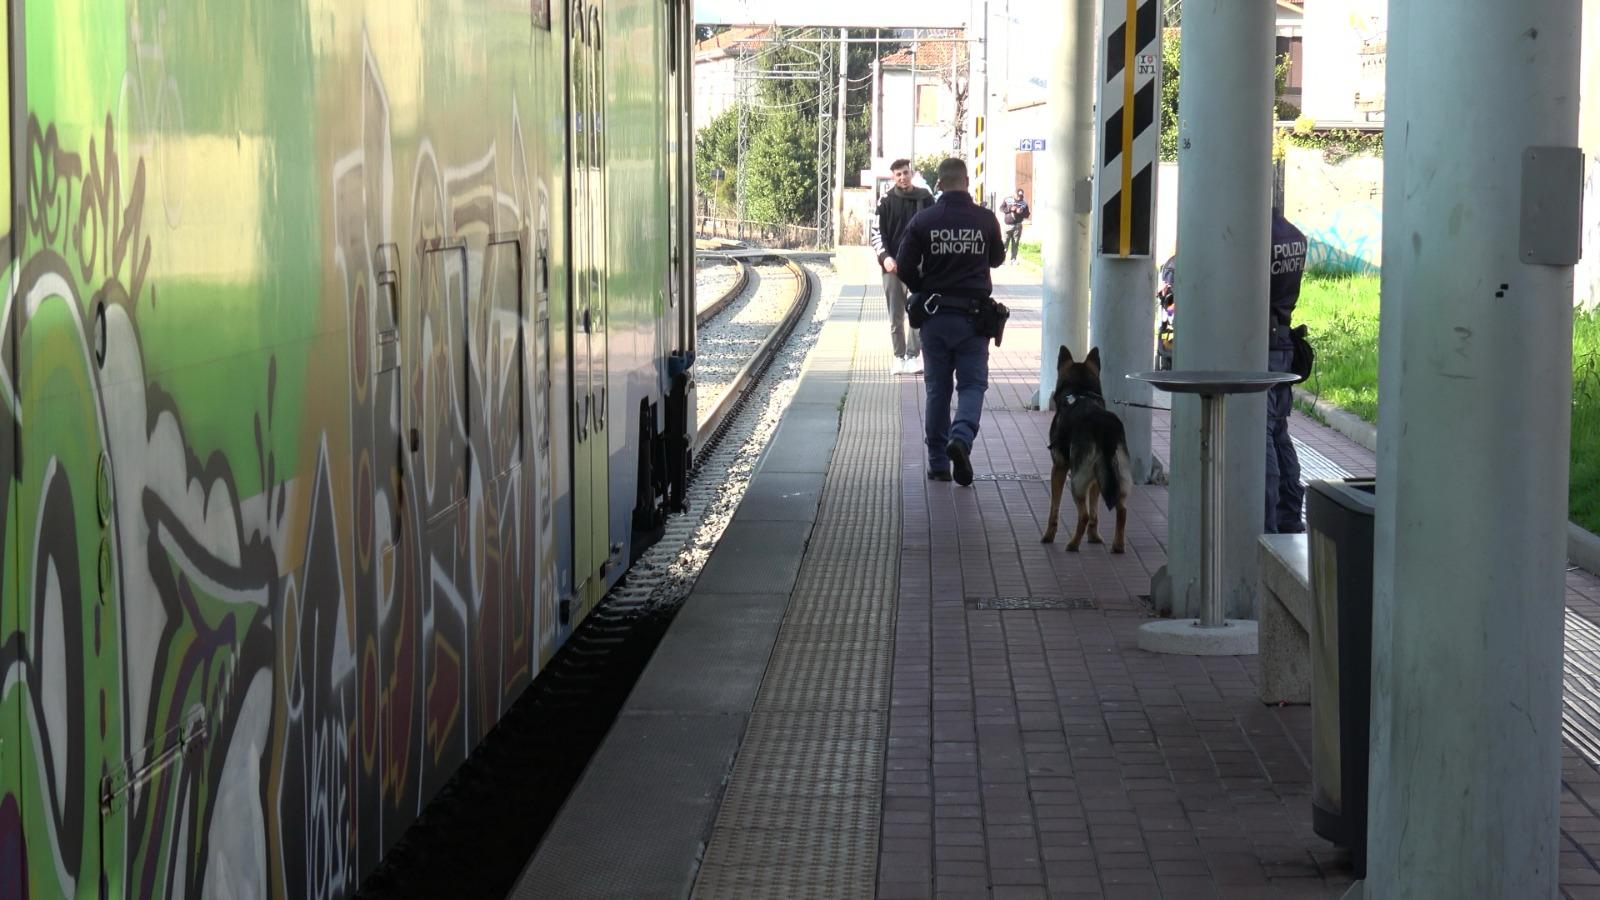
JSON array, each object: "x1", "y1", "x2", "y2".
[{"x1": 922, "y1": 312, "x2": 989, "y2": 472}]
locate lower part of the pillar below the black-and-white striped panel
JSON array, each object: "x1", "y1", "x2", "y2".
[{"x1": 1074, "y1": 256, "x2": 1155, "y2": 484}]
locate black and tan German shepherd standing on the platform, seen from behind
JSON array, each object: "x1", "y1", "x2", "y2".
[{"x1": 1040, "y1": 346, "x2": 1133, "y2": 552}]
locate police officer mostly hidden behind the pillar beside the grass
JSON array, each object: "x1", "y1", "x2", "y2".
[{"x1": 1266, "y1": 210, "x2": 1306, "y2": 535}]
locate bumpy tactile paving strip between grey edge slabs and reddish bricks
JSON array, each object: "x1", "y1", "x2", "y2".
[{"x1": 694, "y1": 293, "x2": 901, "y2": 898}]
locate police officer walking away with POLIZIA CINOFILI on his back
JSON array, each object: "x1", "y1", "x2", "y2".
[{"x1": 894, "y1": 159, "x2": 1005, "y2": 485}]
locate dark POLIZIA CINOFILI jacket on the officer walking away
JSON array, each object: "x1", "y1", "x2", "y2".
[{"x1": 894, "y1": 191, "x2": 1005, "y2": 298}]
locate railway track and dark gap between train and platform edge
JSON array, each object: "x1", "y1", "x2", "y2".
[{"x1": 358, "y1": 248, "x2": 832, "y2": 900}]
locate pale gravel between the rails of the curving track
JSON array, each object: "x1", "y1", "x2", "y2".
[{"x1": 694, "y1": 263, "x2": 795, "y2": 421}]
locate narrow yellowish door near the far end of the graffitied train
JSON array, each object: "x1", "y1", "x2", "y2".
[{"x1": 566, "y1": 0, "x2": 610, "y2": 613}]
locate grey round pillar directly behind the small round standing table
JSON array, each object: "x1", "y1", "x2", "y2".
[{"x1": 1166, "y1": 3, "x2": 1274, "y2": 618}]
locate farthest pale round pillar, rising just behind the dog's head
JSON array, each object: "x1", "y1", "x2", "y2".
[{"x1": 1034, "y1": 0, "x2": 1099, "y2": 408}]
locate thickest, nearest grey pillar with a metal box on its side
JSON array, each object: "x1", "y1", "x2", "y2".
[{"x1": 1356, "y1": 0, "x2": 1581, "y2": 898}]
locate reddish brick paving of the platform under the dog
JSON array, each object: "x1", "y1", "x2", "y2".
[{"x1": 878, "y1": 271, "x2": 1600, "y2": 900}]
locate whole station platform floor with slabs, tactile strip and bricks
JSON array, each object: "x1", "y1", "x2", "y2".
[{"x1": 514, "y1": 251, "x2": 1600, "y2": 900}]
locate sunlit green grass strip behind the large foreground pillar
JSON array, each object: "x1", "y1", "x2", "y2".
[{"x1": 1294, "y1": 274, "x2": 1600, "y2": 533}]
